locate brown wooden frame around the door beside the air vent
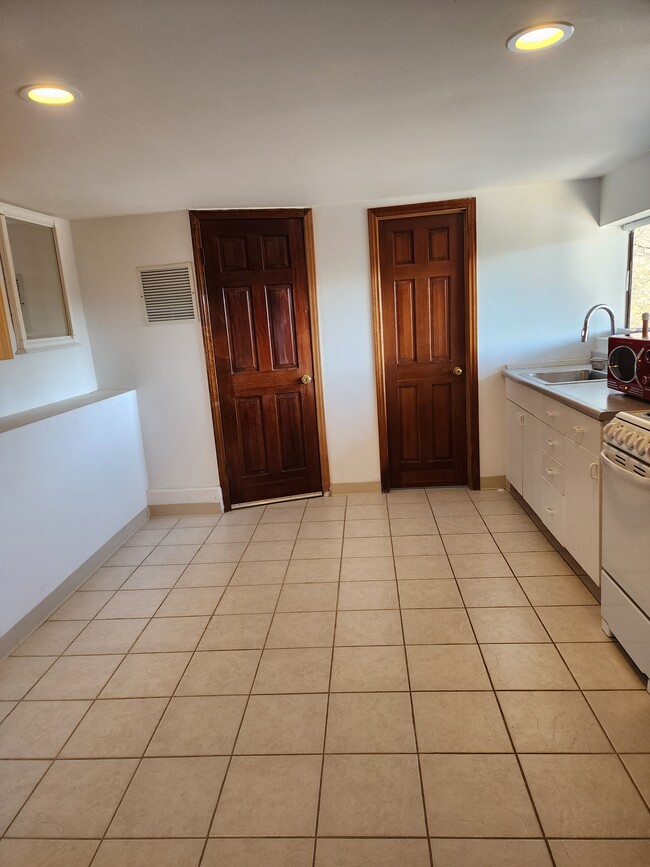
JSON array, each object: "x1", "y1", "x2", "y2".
[{"x1": 188, "y1": 208, "x2": 330, "y2": 512}]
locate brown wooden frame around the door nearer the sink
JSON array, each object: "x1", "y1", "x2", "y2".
[{"x1": 368, "y1": 198, "x2": 481, "y2": 491}]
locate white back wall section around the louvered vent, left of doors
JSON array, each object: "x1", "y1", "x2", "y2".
[{"x1": 73, "y1": 212, "x2": 221, "y2": 504}]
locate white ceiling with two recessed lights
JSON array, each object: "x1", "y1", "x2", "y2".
[{"x1": 0, "y1": 0, "x2": 650, "y2": 218}]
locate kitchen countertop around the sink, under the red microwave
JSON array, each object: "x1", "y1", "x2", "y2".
[{"x1": 503, "y1": 359, "x2": 650, "y2": 421}]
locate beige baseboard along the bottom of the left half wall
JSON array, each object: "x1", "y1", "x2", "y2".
[{"x1": 0, "y1": 508, "x2": 149, "y2": 659}]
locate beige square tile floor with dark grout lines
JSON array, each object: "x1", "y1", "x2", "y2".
[{"x1": 0, "y1": 489, "x2": 650, "y2": 867}]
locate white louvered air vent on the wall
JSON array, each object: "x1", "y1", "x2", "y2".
[{"x1": 139, "y1": 264, "x2": 196, "y2": 323}]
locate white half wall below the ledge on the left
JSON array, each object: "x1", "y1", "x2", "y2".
[{"x1": 0, "y1": 391, "x2": 147, "y2": 638}]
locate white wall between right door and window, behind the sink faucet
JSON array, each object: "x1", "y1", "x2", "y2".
[{"x1": 477, "y1": 180, "x2": 627, "y2": 476}]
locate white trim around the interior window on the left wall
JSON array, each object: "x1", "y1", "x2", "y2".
[{"x1": 0, "y1": 204, "x2": 75, "y2": 355}]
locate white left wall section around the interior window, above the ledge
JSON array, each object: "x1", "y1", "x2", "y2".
[{"x1": 0, "y1": 212, "x2": 97, "y2": 417}]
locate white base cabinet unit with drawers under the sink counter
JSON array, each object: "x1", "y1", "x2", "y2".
[{"x1": 506, "y1": 380, "x2": 602, "y2": 584}]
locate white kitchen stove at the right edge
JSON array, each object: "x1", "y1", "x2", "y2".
[{"x1": 601, "y1": 410, "x2": 650, "y2": 690}]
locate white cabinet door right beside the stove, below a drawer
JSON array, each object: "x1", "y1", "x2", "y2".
[{"x1": 564, "y1": 438, "x2": 600, "y2": 584}]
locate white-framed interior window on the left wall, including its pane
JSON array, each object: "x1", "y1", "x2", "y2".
[{"x1": 0, "y1": 206, "x2": 73, "y2": 353}]
